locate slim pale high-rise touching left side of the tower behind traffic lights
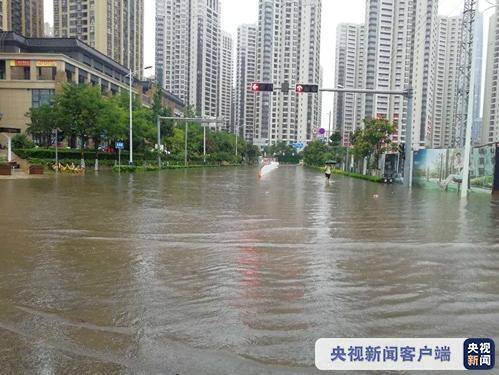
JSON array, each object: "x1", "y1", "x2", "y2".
[{"x1": 234, "y1": 25, "x2": 257, "y2": 142}]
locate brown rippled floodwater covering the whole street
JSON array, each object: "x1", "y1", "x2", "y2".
[{"x1": 0, "y1": 166, "x2": 499, "y2": 375}]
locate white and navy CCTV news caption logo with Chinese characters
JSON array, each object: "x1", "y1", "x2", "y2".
[{"x1": 315, "y1": 338, "x2": 495, "y2": 371}]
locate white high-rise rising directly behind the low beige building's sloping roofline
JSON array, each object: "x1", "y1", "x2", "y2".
[{"x1": 155, "y1": 0, "x2": 221, "y2": 117}]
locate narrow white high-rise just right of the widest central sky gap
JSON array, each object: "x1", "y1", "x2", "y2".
[{"x1": 333, "y1": 23, "x2": 365, "y2": 145}]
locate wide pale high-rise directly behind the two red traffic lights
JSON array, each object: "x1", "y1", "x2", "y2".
[{"x1": 254, "y1": 0, "x2": 322, "y2": 145}]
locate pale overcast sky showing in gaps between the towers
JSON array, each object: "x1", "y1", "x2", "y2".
[{"x1": 45, "y1": 0, "x2": 492, "y2": 126}]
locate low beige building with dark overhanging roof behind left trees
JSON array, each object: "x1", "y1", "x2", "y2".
[{"x1": 0, "y1": 32, "x2": 184, "y2": 141}]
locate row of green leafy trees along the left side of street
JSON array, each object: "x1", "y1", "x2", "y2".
[{"x1": 26, "y1": 83, "x2": 258, "y2": 166}]
